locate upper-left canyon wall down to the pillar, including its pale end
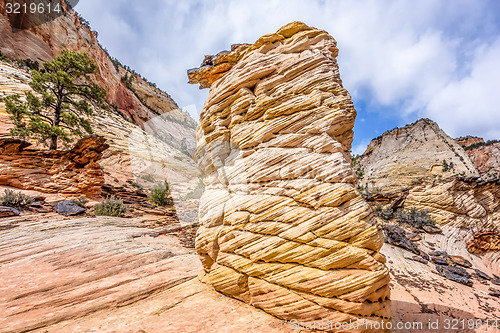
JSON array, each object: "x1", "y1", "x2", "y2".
[{"x1": 0, "y1": 0, "x2": 196, "y2": 152}]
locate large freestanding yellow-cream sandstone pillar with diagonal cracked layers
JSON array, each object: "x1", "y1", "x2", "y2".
[{"x1": 188, "y1": 22, "x2": 390, "y2": 332}]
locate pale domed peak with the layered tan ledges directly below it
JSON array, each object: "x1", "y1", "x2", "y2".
[{"x1": 359, "y1": 119, "x2": 500, "y2": 232}]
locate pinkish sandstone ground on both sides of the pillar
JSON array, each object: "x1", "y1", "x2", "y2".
[{"x1": 0, "y1": 206, "x2": 500, "y2": 333}]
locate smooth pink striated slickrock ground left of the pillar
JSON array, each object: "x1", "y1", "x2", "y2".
[{"x1": 0, "y1": 213, "x2": 296, "y2": 333}]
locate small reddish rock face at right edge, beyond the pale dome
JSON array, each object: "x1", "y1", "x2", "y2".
[{"x1": 457, "y1": 137, "x2": 500, "y2": 181}]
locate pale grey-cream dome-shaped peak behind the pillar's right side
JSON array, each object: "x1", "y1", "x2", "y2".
[{"x1": 359, "y1": 119, "x2": 479, "y2": 193}]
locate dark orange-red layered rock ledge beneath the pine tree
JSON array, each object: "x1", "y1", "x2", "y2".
[{"x1": 0, "y1": 136, "x2": 109, "y2": 197}]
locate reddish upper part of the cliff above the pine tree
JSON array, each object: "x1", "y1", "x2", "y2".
[{"x1": 0, "y1": 0, "x2": 172, "y2": 125}]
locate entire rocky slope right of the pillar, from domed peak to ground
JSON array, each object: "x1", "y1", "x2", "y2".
[{"x1": 357, "y1": 119, "x2": 500, "y2": 322}]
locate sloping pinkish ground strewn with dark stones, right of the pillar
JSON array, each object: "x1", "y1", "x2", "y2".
[{"x1": 381, "y1": 222, "x2": 500, "y2": 332}]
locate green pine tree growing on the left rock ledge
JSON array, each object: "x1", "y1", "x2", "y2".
[{"x1": 5, "y1": 51, "x2": 106, "y2": 150}]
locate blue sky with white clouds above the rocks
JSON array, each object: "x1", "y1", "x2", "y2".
[{"x1": 75, "y1": 0, "x2": 500, "y2": 153}]
